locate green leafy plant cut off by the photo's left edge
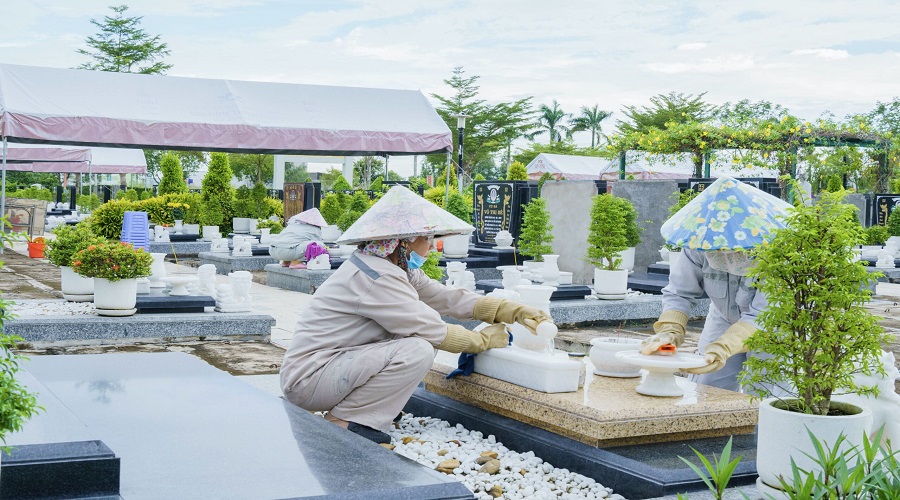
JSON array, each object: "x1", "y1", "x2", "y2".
[{"x1": 0, "y1": 222, "x2": 43, "y2": 452}]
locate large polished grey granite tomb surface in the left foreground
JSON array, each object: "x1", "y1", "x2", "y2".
[{"x1": 9, "y1": 353, "x2": 472, "y2": 499}]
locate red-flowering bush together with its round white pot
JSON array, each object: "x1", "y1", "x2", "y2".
[{"x1": 72, "y1": 242, "x2": 153, "y2": 316}]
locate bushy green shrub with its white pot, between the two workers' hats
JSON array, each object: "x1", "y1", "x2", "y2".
[{"x1": 587, "y1": 194, "x2": 628, "y2": 298}]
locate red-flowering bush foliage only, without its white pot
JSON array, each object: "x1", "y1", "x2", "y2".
[{"x1": 72, "y1": 242, "x2": 153, "y2": 281}]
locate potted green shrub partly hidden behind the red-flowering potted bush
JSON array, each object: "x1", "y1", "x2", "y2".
[{"x1": 47, "y1": 223, "x2": 106, "y2": 302}]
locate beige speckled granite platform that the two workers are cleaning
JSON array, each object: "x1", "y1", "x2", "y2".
[{"x1": 425, "y1": 363, "x2": 758, "y2": 447}]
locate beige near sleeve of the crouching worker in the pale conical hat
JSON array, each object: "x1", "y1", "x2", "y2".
[{"x1": 356, "y1": 274, "x2": 458, "y2": 346}]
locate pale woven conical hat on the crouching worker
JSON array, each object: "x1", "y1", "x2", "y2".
[{"x1": 337, "y1": 185, "x2": 475, "y2": 245}]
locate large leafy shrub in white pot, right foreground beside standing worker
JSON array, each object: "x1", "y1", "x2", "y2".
[{"x1": 741, "y1": 190, "x2": 891, "y2": 496}]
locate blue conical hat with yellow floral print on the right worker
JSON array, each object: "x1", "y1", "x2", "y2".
[{"x1": 659, "y1": 177, "x2": 791, "y2": 251}]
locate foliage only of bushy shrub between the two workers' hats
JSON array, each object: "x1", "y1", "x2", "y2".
[{"x1": 587, "y1": 194, "x2": 628, "y2": 271}]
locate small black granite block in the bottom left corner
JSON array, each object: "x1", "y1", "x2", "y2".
[{"x1": 0, "y1": 441, "x2": 121, "y2": 500}]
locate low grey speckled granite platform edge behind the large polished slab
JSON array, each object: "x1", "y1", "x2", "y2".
[{"x1": 4, "y1": 312, "x2": 275, "y2": 347}]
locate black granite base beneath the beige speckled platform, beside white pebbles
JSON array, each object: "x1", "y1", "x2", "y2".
[{"x1": 403, "y1": 386, "x2": 757, "y2": 499}]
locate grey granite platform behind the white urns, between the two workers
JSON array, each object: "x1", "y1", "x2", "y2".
[{"x1": 443, "y1": 295, "x2": 709, "y2": 329}]
